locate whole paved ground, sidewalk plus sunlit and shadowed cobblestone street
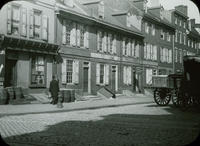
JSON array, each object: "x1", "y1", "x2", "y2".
[{"x1": 0, "y1": 97, "x2": 200, "y2": 146}]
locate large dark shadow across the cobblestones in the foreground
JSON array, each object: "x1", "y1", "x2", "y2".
[{"x1": 1, "y1": 114, "x2": 199, "y2": 146}]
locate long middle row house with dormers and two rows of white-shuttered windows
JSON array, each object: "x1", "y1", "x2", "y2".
[{"x1": 57, "y1": 1, "x2": 143, "y2": 95}]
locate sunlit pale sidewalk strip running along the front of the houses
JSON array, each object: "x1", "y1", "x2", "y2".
[{"x1": 0, "y1": 95, "x2": 154, "y2": 116}]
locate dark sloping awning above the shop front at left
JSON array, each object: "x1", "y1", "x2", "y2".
[{"x1": 2, "y1": 36, "x2": 59, "y2": 55}]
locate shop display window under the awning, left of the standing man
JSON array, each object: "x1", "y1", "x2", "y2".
[{"x1": 31, "y1": 56, "x2": 45, "y2": 85}]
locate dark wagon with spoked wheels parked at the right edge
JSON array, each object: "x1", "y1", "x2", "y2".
[{"x1": 152, "y1": 56, "x2": 200, "y2": 109}]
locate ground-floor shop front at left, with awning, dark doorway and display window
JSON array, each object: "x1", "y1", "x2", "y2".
[{"x1": 2, "y1": 37, "x2": 58, "y2": 92}]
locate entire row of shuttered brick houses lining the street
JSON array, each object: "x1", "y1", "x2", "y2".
[{"x1": 0, "y1": 0, "x2": 199, "y2": 95}]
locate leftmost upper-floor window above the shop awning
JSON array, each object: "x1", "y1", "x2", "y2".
[{"x1": 7, "y1": 5, "x2": 20, "y2": 35}]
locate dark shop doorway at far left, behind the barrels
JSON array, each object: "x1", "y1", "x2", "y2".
[{"x1": 5, "y1": 59, "x2": 17, "y2": 87}]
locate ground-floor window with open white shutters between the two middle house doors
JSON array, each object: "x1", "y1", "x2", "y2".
[{"x1": 96, "y1": 63, "x2": 109, "y2": 85}]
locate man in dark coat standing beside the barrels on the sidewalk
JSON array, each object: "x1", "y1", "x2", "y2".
[{"x1": 49, "y1": 76, "x2": 59, "y2": 104}]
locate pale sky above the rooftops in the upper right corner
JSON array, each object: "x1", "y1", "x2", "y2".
[{"x1": 148, "y1": 0, "x2": 200, "y2": 23}]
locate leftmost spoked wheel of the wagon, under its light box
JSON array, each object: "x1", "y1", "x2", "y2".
[{"x1": 154, "y1": 89, "x2": 171, "y2": 106}]
